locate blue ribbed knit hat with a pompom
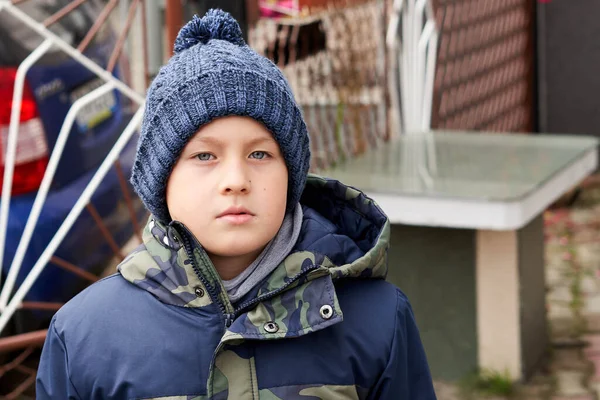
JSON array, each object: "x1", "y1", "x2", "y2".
[{"x1": 131, "y1": 10, "x2": 310, "y2": 223}]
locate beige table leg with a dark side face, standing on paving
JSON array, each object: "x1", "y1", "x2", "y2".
[{"x1": 475, "y1": 217, "x2": 548, "y2": 380}]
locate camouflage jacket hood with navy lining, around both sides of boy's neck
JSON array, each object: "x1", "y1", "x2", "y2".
[{"x1": 118, "y1": 175, "x2": 390, "y2": 307}]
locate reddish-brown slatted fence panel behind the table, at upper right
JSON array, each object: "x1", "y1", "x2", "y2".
[{"x1": 432, "y1": 0, "x2": 534, "y2": 132}]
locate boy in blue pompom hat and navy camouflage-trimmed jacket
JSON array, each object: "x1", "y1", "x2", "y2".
[{"x1": 37, "y1": 10, "x2": 435, "y2": 400}]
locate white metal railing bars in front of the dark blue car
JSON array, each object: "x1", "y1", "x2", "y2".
[{"x1": 0, "y1": 0, "x2": 144, "y2": 332}]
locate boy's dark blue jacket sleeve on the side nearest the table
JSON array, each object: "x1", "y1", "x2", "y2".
[{"x1": 369, "y1": 291, "x2": 436, "y2": 400}]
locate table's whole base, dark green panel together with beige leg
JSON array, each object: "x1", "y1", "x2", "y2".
[{"x1": 388, "y1": 216, "x2": 548, "y2": 380}]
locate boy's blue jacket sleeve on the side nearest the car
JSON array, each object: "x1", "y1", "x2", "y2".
[{"x1": 36, "y1": 318, "x2": 80, "y2": 400}]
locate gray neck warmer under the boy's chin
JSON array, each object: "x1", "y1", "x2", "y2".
[{"x1": 223, "y1": 203, "x2": 302, "y2": 303}]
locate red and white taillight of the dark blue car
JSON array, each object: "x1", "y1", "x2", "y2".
[{"x1": 0, "y1": 68, "x2": 48, "y2": 194}]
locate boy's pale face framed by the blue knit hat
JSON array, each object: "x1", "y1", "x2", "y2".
[{"x1": 167, "y1": 116, "x2": 288, "y2": 257}]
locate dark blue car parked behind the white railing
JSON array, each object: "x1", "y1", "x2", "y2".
[{"x1": 0, "y1": 0, "x2": 144, "y2": 328}]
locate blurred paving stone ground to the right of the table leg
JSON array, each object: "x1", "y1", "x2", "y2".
[{"x1": 435, "y1": 177, "x2": 600, "y2": 400}]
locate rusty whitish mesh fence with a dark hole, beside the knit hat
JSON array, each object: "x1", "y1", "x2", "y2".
[{"x1": 249, "y1": 1, "x2": 386, "y2": 169}]
